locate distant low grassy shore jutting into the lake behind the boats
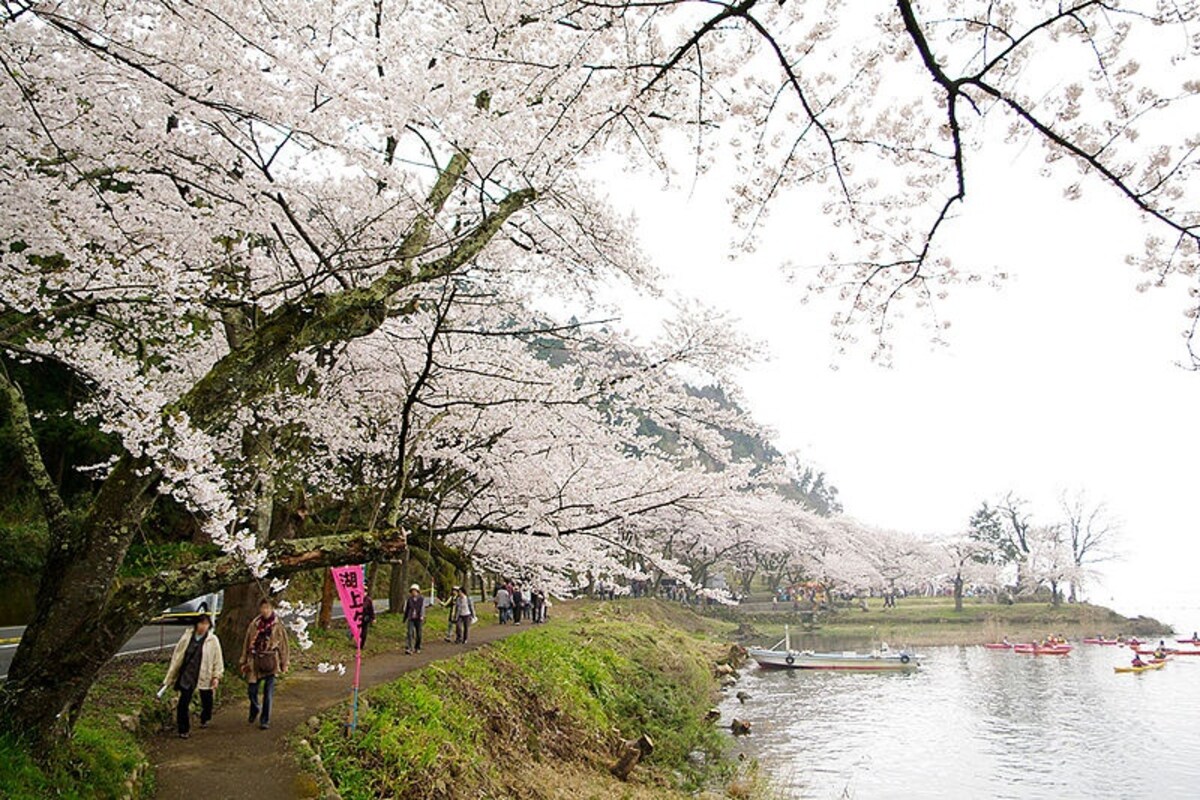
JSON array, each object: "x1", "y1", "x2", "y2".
[{"x1": 733, "y1": 597, "x2": 1170, "y2": 645}]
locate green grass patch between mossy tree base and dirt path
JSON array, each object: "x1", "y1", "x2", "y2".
[{"x1": 0, "y1": 662, "x2": 169, "y2": 800}]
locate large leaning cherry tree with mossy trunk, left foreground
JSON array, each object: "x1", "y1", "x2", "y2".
[{"x1": 0, "y1": 2, "x2": 648, "y2": 739}]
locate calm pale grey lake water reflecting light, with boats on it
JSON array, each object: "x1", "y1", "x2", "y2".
[{"x1": 721, "y1": 645, "x2": 1200, "y2": 800}]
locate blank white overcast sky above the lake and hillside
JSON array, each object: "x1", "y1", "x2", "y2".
[{"x1": 597, "y1": 126, "x2": 1200, "y2": 632}]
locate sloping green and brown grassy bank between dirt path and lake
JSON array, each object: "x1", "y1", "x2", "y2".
[{"x1": 299, "y1": 603, "x2": 744, "y2": 800}]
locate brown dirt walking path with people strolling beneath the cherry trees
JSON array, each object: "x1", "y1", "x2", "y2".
[{"x1": 151, "y1": 625, "x2": 516, "y2": 800}]
